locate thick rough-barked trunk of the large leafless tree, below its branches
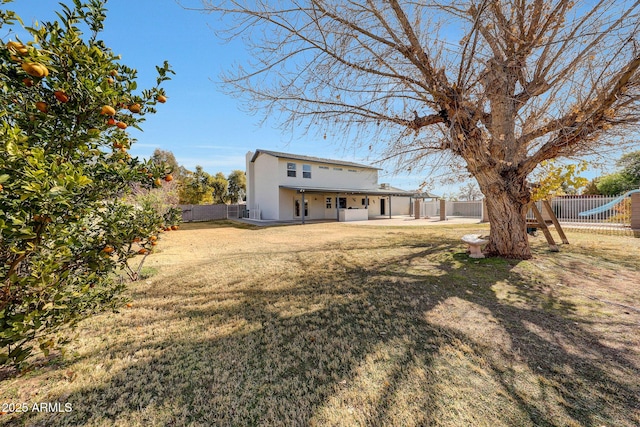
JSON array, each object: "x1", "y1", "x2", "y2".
[{"x1": 478, "y1": 172, "x2": 531, "y2": 259}]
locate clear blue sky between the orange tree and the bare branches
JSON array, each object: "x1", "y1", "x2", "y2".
[{"x1": 1, "y1": 0, "x2": 430, "y2": 190}]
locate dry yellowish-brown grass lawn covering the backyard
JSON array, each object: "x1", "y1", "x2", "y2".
[{"x1": 0, "y1": 222, "x2": 640, "y2": 427}]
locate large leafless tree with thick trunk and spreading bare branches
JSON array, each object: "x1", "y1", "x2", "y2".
[{"x1": 198, "y1": 0, "x2": 640, "y2": 259}]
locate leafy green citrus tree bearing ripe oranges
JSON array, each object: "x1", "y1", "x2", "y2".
[{"x1": 0, "y1": 0, "x2": 172, "y2": 364}]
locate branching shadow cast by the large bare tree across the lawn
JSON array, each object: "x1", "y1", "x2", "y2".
[{"x1": 15, "y1": 242, "x2": 640, "y2": 426}]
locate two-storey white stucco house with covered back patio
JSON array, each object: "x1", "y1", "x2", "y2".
[{"x1": 246, "y1": 150, "x2": 414, "y2": 222}]
